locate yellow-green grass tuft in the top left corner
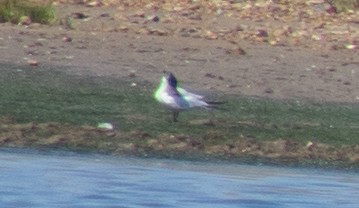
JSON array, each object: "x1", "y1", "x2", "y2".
[{"x1": 0, "y1": 0, "x2": 55, "y2": 24}]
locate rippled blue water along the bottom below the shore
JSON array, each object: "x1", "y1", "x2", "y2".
[{"x1": 0, "y1": 150, "x2": 359, "y2": 208}]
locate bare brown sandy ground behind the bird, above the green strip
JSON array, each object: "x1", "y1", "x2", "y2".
[{"x1": 0, "y1": 1, "x2": 359, "y2": 102}]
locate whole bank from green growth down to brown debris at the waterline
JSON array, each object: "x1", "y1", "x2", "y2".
[{"x1": 0, "y1": 64, "x2": 359, "y2": 166}]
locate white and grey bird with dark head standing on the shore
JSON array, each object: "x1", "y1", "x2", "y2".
[{"x1": 154, "y1": 72, "x2": 224, "y2": 122}]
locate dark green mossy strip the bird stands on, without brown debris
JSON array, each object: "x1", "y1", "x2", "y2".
[{"x1": 0, "y1": 64, "x2": 359, "y2": 145}]
